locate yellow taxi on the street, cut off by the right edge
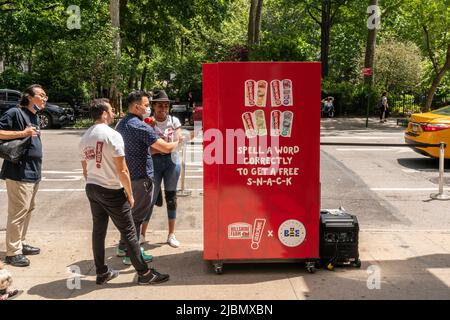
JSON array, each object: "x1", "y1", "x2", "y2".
[{"x1": 405, "y1": 106, "x2": 450, "y2": 159}]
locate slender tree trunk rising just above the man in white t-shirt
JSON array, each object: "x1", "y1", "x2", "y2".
[{"x1": 109, "y1": 0, "x2": 122, "y2": 114}]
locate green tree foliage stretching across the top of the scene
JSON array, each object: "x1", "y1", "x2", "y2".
[{"x1": 0, "y1": 0, "x2": 450, "y2": 114}]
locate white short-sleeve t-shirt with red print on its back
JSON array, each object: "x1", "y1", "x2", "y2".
[{"x1": 79, "y1": 124, "x2": 125, "y2": 189}]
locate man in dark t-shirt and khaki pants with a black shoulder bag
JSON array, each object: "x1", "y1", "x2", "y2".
[{"x1": 0, "y1": 84, "x2": 47, "y2": 267}]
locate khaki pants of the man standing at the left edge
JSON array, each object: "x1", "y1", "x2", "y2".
[{"x1": 6, "y1": 179, "x2": 39, "y2": 257}]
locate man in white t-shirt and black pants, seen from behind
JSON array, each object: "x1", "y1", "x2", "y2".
[{"x1": 80, "y1": 99, "x2": 169, "y2": 284}]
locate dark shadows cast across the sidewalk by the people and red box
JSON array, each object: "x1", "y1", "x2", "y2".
[{"x1": 28, "y1": 250, "x2": 450, "y2": 299}]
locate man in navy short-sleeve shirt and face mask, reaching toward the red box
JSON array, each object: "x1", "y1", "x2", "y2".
[{"x1": 116, "y1": 91, "x2": 178, "y2": 264}]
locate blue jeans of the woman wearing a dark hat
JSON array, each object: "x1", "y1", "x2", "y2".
[{"x1": 144, "y1": 154, "x2": 181, "y2": 222}]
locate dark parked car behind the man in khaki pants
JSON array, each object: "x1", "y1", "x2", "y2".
[{"x1": 0, "y1": 89, "x2": 75, "y2": 129}]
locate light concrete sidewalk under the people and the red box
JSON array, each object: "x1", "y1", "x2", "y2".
[{"x1": 0, "y1": 230, "x2": 450, "y2": 300}]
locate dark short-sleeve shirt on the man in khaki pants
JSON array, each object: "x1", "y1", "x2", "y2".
[{"x1": 0, "y1": 108, "x2": 42, "y2": 182}]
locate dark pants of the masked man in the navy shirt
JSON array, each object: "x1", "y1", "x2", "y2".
[{"x1": 119, "y1": 178, "x2": 153, "y2": 250}]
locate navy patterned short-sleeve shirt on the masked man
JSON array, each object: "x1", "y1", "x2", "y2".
[{"x1": 116, "y1": 113, "x2": 158, "y2": 180}]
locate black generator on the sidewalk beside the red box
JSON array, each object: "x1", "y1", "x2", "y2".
[{"x1": 319, "y1": 208, "x2": 361, "y2": 270}]
